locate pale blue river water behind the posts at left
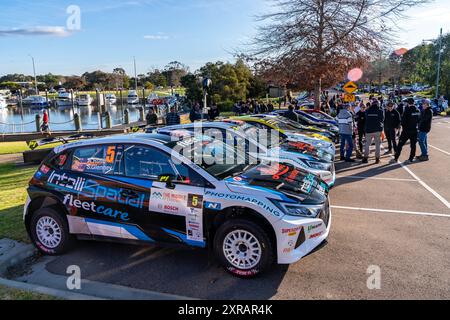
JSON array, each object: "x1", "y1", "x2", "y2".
[{"x1": 0, "y1": 105, "x2": 139, "y2": 134}]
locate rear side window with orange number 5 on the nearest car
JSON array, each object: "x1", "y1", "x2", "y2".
[{"x1": 71, "y1": 145, "x2": 121, "y2": 175}]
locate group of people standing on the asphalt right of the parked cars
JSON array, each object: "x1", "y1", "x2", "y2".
[{"x1": 333, "y1": 96, "x2": 433, "y2": 164}]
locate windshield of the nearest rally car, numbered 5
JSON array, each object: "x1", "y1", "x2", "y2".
[{"x1": 173, "y1": 136, "x2": 252, "y2": 179}]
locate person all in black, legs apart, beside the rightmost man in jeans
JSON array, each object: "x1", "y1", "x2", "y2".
[{"x1": 395, "y1": 98, "x2": 420, "y2": 163}]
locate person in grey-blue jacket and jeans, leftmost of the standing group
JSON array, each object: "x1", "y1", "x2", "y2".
[{"x1": 337, "y1": 104, "x2": 355, "y2": 162}]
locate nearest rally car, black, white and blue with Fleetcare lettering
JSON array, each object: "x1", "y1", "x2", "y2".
[{"x1": 24, "y1": 134, "x2": 331, "y2": 277}]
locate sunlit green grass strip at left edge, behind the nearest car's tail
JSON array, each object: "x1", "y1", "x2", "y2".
[{"x1": 0, "y1": 163, "x2": 36, "y2": 242}]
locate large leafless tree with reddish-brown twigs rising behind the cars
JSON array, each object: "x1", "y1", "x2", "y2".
[{"x1": 248, "y1": 0, "x2": 428, "y2": 108}]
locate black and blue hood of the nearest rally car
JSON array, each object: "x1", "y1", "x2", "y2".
[{"x1": 225, "y1": 162, "x2": 329, "y2": 203}]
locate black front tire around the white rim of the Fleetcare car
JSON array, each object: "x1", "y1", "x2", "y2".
[{"x1": 214, "y1": 219, "x2": 275, "y2": 279}]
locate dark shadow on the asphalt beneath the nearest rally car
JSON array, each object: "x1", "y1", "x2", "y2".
[{"x1": 46, "y1": 241, "x2": 288, "y2": 300}]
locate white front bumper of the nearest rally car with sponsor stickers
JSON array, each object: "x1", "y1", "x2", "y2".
[{"x1": 275, "y1": 202, "x2": 331, "y2": 264}]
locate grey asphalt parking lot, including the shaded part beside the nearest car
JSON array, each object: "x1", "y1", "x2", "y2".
[{"x1": 11, "y1": 118, "x2": 450, "y2": 299}]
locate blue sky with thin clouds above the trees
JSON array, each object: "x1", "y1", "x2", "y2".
[{"x1": 0, "y1": 0, "x2": 450, "y2": 75}]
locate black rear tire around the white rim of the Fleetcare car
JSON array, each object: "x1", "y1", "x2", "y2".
[{"x1": 30, "y1": 208, "x2": 74, "y2": 256}]
